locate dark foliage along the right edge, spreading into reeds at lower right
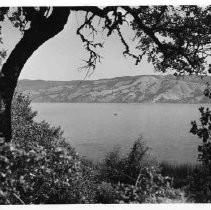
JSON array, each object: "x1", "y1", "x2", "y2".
[{"x1": 157, "y1": 85, "x2": 211, "y2": 203}]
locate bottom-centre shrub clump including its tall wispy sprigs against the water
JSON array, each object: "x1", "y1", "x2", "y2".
[{"x1": 97, "y1": 138, "x2": 185, "y2": 203}]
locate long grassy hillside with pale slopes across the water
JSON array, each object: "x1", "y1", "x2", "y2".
[{"x1": 17, "y1": 75, "x2": 211, "y2": 103}]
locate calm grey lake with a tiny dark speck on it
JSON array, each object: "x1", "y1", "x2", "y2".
[{"x1": 32, "y1": 103, "x2": 211, "y2": 163}]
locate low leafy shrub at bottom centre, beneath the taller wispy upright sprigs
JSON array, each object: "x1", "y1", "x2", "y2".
[{"x1": 96, "y1": 167, "x2": 187, "y2": 203}]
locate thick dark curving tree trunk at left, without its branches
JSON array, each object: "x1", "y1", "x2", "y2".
[{"x1": 0, "y1": 7, "x2": 70, "y2": 142}]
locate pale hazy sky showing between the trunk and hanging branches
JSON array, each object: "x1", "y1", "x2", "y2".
[{"x1": 0, "y1": 9, "x2": 157, "y2": 80}]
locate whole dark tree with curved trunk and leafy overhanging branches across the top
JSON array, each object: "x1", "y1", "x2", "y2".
[{"x1": 0, "y1": 6, "x2": 211, "y2": 142}]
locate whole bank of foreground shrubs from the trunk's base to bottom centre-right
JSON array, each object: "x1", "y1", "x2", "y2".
[{"x1": 0, "y1": 94, "x2": 190, "y2": 204}]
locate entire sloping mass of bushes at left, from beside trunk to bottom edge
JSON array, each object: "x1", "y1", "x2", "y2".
[{"x1": 0, "y1": 95, "x2": 95, "y2": 204}]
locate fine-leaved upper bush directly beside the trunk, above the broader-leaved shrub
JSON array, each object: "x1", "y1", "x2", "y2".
[{"x1": 12, "y1": 94, "x2": 68, "y2": 151}]
